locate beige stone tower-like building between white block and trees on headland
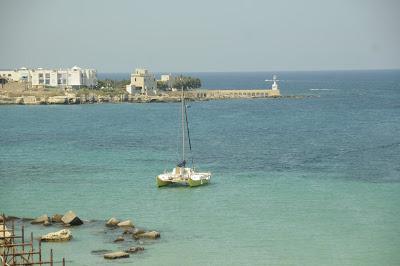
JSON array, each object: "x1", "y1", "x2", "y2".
[{"x1": 126, "y1": 68, "x2": 157, "y2": 95}]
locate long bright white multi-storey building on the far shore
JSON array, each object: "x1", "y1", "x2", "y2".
[{"x1": 30, "y1": 66, "x2": 97, "y2": 88}]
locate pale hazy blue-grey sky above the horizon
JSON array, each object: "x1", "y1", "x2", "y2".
[{"x1": 0, "y1": 0, "x2": 400, "y2": 72}]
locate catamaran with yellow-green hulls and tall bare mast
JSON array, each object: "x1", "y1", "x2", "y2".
[{"x1": 156, "y1": 88, "x2": 211, "y2": 187}]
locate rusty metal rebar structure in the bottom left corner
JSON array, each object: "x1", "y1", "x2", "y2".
[{"x1": 0, "y1": 214, "x2": 65, "y2": 266}]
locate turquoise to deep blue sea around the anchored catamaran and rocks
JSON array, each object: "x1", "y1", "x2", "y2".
[{"x1": 0, "y1": 70, "x2": 400, "y2": 265}]
